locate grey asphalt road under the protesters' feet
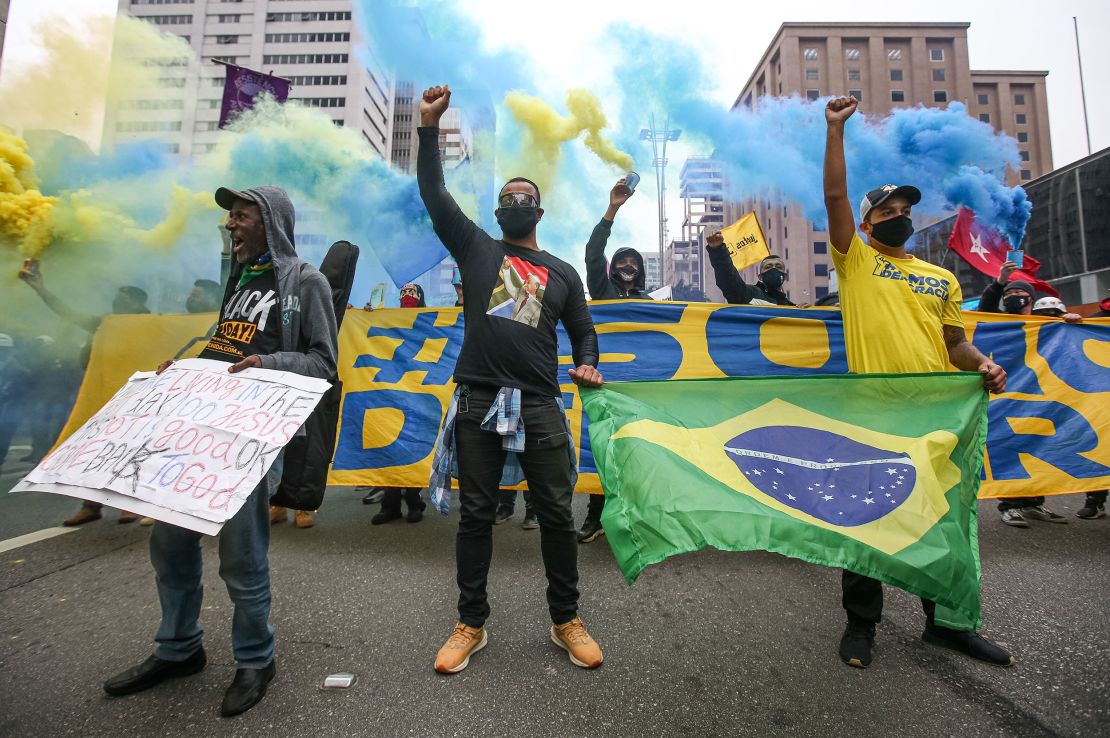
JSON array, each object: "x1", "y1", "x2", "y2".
[{"x1": 0, "y1": 465, "x2": 1110, "y2": 738}]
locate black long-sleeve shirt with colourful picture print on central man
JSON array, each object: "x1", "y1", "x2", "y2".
[{"x1": 416, "y1": 128, "x2": 597, "y2": 397}]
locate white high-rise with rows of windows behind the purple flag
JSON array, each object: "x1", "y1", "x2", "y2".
[{"x1": 105, "y1": 0, "x2": 394, "y2": 161}]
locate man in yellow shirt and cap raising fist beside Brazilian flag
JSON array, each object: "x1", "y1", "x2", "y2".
[{"x1": 825, "y1": 92, "x2": 1013, "y2": 668}]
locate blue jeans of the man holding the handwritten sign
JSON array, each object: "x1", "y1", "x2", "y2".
[{"x1": 150, "y1": 456, "x2": 282, "y2": 669}]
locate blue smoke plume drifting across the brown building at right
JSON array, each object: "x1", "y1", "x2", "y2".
[{"x1": 606, "y1": 24, "x2": 1031, "y2": 244}]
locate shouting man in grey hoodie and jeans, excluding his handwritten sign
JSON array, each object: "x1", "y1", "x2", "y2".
[{"x1": 104, "y1": 186, "x2": 337, "y2": 717}]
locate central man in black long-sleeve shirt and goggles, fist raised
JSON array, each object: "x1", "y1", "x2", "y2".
[{"x1": 416, "y1": 87, "x2": 602, "y2": 674}]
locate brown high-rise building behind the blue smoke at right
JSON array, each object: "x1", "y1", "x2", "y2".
[{"x1": 726, "y1": 22, "x2": 1052, "y2": 303}]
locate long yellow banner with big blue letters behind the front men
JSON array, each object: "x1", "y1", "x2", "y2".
[{"x1": 62, "y1": 301, "x2": 1110, "y2": 497}]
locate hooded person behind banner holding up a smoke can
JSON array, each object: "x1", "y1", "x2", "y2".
[{"x1": 578, "y1": 176, "x2": 652, "y2": 544}]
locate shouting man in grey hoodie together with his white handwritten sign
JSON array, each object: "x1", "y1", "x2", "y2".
[{"x1": 16, "y1": 186, "x2": 337, "y2": 717}]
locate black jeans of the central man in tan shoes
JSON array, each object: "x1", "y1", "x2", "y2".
[{"x1": 455, "y1": 386, "x2": 578, "y2": 628}]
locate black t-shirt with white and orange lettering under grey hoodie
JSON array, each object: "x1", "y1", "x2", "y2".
[{"x1": 200, "y1": 269, "x2": 281, "y2": 362}]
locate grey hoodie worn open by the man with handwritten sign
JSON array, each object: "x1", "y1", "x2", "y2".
[{"x1": 217, "y1": 186, "x2": 339, "y2": 381}]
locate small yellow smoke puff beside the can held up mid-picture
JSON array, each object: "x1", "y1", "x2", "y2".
[{"x1": 505, "y1": 90, "x2": 633, "y2": 190}]
